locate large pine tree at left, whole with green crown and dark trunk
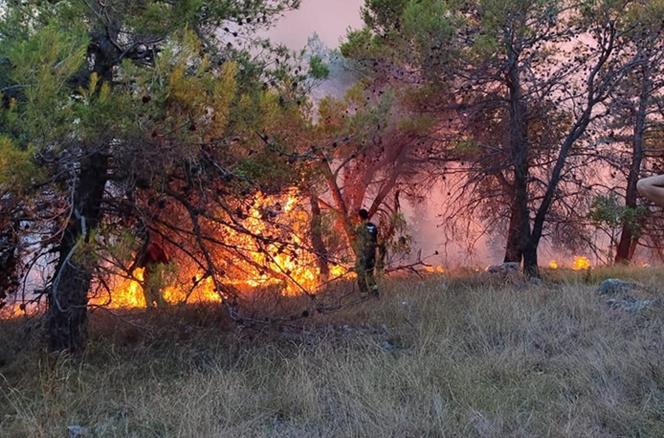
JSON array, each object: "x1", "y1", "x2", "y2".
[{"x1": 0, "y1": 0, "x2": 298, "y2": 352}]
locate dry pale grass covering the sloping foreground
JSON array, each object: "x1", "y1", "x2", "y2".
[{"x1": 0, "y1": 271, "x2": 664, "y2": 437}]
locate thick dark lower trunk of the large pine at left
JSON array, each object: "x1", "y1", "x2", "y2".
[{"x1": 48, "y1": 153, "x2": 108, "y2": 353}]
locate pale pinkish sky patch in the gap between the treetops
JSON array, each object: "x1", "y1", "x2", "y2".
[{"x1": 270, "y1": 0, "x2": 363, "y2": 49}]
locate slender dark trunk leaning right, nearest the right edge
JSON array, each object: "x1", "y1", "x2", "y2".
[{"x1": 615, "y1": 68, "x2": 650, "y2": 264}]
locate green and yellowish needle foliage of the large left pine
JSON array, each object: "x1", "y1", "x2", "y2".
[{"x1": 0, "y1": 0, "x2": 306, "y2": 296}]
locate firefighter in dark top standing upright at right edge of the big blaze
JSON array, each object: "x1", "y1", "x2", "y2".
[{"x1": 355, "y1": 209, "x2": 380, "y2": 298}]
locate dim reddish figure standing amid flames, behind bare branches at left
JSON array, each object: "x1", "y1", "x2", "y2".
[{"x1": 137, "y1": 235, "x2": 169, "y2": 308}]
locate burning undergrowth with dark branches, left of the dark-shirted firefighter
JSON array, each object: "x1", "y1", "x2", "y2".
[{"x1": 92, "y1": 189, "x2": 349, "y2": 308}]
